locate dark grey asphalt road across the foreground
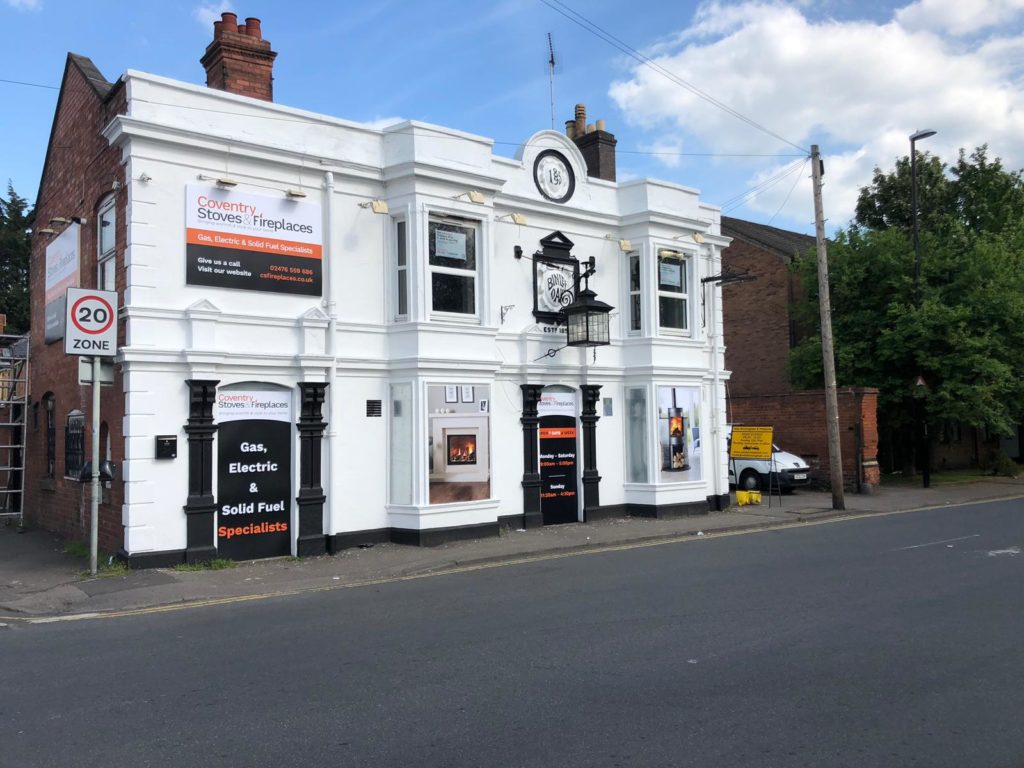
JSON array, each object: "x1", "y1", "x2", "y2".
[{"x1": 0, "y1": 502, "x2": 1024, "y2": 768}]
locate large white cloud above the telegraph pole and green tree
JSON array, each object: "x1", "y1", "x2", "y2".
[{"x1": 609, "y1": 0, "x2": 1024, "y2": 225}]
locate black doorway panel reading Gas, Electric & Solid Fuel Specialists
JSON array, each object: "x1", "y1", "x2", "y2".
[{"x1": 216, "y1": 389, "x2": 292, "y2": 560}]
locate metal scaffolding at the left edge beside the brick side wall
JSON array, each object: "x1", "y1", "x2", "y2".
[{"x1": 0, "y1": 334, "x2": 29, "y2": 528}]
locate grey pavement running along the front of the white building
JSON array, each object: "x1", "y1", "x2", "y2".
[{"x1": 0, "y1": 477, "x2": 1024, "y2": 629}]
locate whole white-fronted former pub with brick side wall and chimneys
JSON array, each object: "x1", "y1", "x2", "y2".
[{"x1": 26, "y1": 13, "x2": 728, "y2": 565}]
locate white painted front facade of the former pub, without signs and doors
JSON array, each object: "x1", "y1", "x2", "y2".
[{"x1": 104, "y1": 72, "x2": 728, "y2": 557}]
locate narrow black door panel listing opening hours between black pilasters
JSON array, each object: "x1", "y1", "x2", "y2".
[{"x1": 537, "y1": 392, "x2": 580, "y2": 525}]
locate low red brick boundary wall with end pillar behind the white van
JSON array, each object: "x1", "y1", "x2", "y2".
[{"x1": 728, "y1": 387, "x2": 879, "y2": 489}]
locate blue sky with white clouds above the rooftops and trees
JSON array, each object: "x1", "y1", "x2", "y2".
[{"x1": 0, "y1": 0, "x2": 1024, "y2": 232}]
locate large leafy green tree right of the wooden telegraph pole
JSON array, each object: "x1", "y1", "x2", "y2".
[{"x1": 791, "y1": 146, "x2": 1024, "y2": 465}]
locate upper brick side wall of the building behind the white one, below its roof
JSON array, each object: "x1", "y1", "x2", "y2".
[{"x1": 722, "y1": 239, "x2": 791, "y2": 396}]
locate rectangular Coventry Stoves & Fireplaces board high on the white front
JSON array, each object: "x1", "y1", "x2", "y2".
[{"x1": 185, "y1": 184, "x2": 323, "y2": 296}]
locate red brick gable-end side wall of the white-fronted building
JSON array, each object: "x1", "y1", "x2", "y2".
[{"x1": 25, "y1": 54, "x2": 126, "y2": 551}]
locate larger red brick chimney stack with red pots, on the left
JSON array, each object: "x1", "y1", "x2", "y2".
[{"x1": 200, "y1": 13, "x2": 278, "y2": 101}]
